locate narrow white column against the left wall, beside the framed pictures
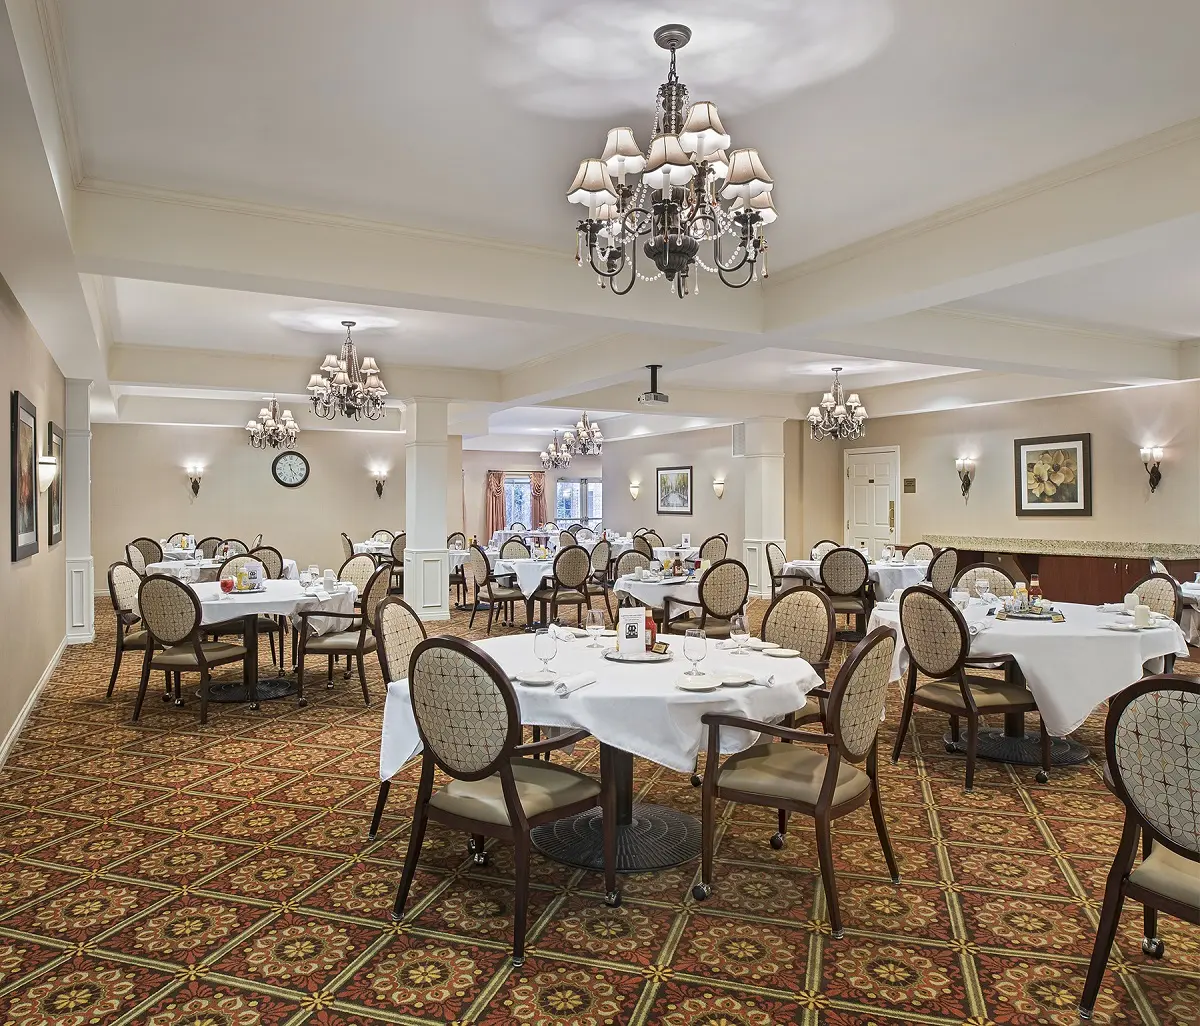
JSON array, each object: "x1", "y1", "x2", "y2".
[{"x1": 61, "y1": 378, "x2": 96, "y2": 644}]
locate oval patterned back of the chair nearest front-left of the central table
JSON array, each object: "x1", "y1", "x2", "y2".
[{"x1": 408, "y1": 637, "x2": 521, "y2": 780}]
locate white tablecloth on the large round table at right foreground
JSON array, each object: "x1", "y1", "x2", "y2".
[{"x1": 868, "y1": 602, "x2": 1188, "y2": 737}]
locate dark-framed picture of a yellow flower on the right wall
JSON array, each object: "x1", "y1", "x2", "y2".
[{"x1": 1013, "y1": 433, "x2": 1092, "y2": 516}]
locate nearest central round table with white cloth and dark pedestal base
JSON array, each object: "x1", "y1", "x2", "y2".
[{"x1": 379, "y1": 632, "x2": 823, "y2": 872}]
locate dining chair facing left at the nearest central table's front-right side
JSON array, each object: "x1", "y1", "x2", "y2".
[{"x1": 692, "y1": 624, "x2": 900, "y2": 940}]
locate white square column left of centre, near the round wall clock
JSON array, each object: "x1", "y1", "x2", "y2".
[{"x1": 404, "y1": 398, "x2": 450, "y2": 620}]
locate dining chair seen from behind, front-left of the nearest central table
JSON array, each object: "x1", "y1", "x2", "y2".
[{"x1": 392, "y1": 637, "x2": 620, "y2": 966}]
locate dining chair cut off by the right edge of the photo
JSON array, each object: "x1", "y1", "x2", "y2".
[{"x1": 1079, "y1": 673, "x2": 1200, "y2": 1022}]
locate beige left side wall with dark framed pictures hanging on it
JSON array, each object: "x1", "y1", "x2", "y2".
[{"x1": 0, "y1": 278, "x2": 67, "y2": 738}]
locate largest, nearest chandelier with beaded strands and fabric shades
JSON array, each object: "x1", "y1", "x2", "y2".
[{"x1": 566, "y1": 25, "x2": 776, "y2": 299}]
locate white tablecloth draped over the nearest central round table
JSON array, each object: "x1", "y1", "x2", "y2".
[{"x1": 379, "y1": 635, "x2": 822, "y2": 780}]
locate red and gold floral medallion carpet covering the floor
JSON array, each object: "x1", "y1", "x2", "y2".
[{"x1": 0, "y1": 601, "x2": 1200, "y2": 1026}]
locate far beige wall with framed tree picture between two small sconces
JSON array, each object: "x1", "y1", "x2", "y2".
[{"x1": 602, "y1": 427, "x2": 745, "y2": 544}]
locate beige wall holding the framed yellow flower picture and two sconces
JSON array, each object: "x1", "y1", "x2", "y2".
[{"x1": 820, "y1": 382, "x2": 1200, "y2": 544}]
